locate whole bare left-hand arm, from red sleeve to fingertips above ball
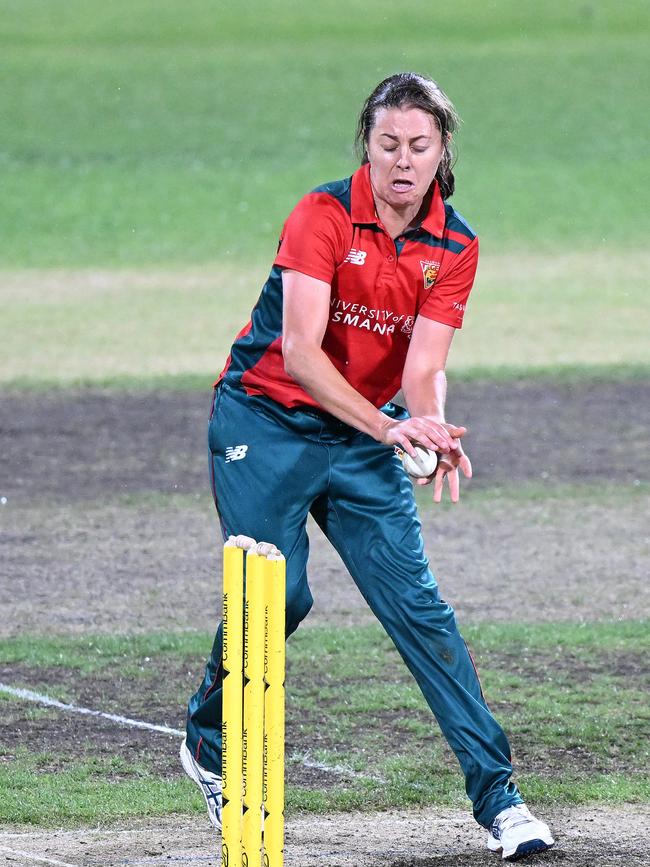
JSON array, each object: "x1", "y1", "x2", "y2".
[{"x1": 282, "y1": 270, "x2": 457, "y2": 455}]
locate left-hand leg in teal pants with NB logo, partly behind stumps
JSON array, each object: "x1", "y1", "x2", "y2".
[{"x1": 187, "y1": 391, "x2": 329, "y2": 774}]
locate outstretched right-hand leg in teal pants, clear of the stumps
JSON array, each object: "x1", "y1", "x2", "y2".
[{"x1": 315, "y1": 434, "x2": 522, "y2": 827}]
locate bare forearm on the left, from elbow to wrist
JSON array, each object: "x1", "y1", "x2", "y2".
[{"x1": 284, "y1": 345, "x2": 391, "y2": 441}]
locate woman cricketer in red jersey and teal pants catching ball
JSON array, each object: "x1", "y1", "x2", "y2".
[{"x1": 181, "y1": 73, "x2": 553, "y2": 858}]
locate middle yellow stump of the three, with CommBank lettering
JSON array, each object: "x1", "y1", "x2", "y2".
[{"x1": 242, "y1": 551, "x2": 266, "y2": 867}]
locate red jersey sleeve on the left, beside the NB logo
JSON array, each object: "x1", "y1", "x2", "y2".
[{"x1": 273, "y1": 193, "x2": 349, "y2": 283}]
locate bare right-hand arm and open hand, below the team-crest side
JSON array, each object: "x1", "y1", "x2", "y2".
[{"x1": 402, "y1": 316, "x2": 472, "y2": 502}]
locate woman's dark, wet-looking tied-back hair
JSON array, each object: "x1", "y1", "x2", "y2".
[{"x1": 356, "y1": 72, "x2": 460, "y2": 199}]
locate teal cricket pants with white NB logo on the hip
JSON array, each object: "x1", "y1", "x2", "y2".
[{"x1": 187, "y1": 383, "x2": 522, "y2": 827}]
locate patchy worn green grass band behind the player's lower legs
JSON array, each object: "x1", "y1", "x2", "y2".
[{"x1": 0, "y1": 621, "x2": 650, "y2": 824}]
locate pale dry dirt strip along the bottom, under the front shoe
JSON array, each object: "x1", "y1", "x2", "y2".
[{"x1": 0, "y1": 806, "x2": 650, "y2": 867}]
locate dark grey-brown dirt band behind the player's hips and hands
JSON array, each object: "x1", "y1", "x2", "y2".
[{"x1": 0, "y1": 380, "x2": 650, "y2": 505}]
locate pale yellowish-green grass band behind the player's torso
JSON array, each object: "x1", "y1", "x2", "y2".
[{"x1": 0, "y1": 252, "x2": 650, "y2": 391}]
